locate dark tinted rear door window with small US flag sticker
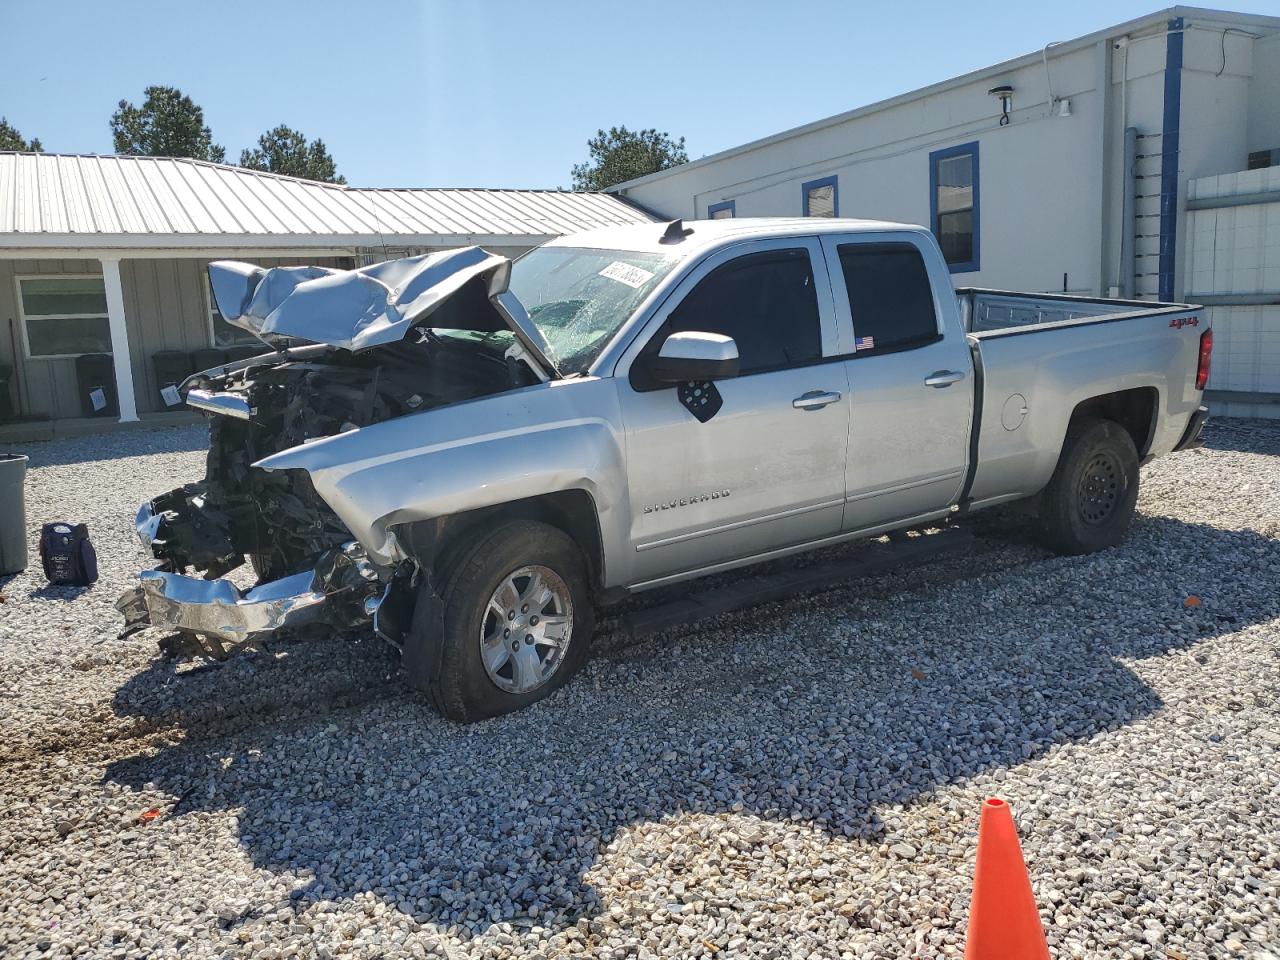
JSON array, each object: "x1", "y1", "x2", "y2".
[{"x1": 838, "y1": 243, "x2": 938, "y2": 357}]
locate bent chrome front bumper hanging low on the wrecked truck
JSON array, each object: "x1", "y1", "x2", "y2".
[{"x1": 141, "y1": 570, "x2": 325, "y2": 643}]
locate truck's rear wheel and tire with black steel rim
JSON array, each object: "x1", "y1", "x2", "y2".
[{"x1": 1039, "y1": 420, "x2": 1138, "y2": 554}]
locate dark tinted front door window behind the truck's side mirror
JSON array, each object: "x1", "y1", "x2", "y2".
[{"x1": 654, "y1": 250, "x2": 822, "y2": 374}]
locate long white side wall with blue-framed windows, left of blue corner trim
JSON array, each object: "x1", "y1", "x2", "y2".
[{"x1": 626, "y1": 40, "x2": 1116, "y2": 292}]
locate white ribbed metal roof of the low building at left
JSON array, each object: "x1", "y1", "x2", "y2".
[{"x1": 0, "y1": 152, "x2": 653, "y2": 248}]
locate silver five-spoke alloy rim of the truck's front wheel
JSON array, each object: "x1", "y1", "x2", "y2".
[{"x1": 480, "y1": 564, "x2": 573, "y2": 694}]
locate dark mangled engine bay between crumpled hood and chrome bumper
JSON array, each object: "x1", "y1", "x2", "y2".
[{"x1": 152, "y1": 330, "x2": 529, "y2": 580}]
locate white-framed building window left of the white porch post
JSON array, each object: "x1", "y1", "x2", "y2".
[{"x1": 18, "y1": 276, "x2": 111, "y2": 357}]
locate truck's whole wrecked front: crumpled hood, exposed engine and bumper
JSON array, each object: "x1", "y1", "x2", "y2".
[{"x1": 116, "y1": 248, "x2": 545, "y2": 657}]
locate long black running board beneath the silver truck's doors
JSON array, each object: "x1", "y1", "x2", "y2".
[{"x1": 618, "y1": 527, "x2": 973, "y2": 640}]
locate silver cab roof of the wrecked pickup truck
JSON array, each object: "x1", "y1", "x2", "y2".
[{"x1": 547, "y1": 216, "x2": 928, "y2": 255}]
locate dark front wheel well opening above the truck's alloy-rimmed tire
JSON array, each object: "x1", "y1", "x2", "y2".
[{"x1": 401, "y1": 490, "x2": 604, "y2": 588}]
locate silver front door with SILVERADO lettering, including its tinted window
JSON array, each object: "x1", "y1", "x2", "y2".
[{"x1": 616, "y1": 237, "x2": 849, "y2": 585}]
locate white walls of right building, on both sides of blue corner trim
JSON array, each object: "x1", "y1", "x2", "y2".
[{"x1": 623, "y1": 8, "x2": 1280, "y2": 308}]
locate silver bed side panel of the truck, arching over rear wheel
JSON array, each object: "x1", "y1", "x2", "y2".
[{"x1": 970, "y1": 308, "x2": 1208, "y2": 507}]
